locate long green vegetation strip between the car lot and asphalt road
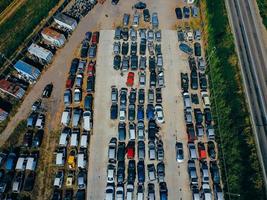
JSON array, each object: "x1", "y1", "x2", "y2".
[{"x1": 201, "y1": 0, "x2": 266, "y2": 200}]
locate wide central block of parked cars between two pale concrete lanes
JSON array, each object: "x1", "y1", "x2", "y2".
[{"x1": 106, "y1": 10, "x2": 167, "y2": 200}]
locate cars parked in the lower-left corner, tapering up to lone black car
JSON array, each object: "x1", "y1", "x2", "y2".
[{"x1": 0, "y1": 83, "x2": 53, "y2": 199}]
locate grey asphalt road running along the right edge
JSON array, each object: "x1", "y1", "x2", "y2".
[{"x1": 226, "y1": 0, "x2": 267, "y2": 191}]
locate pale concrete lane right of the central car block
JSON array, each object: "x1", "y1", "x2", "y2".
[{"x1": 162, "y1": 30, "x2": 191, "y2": 199}]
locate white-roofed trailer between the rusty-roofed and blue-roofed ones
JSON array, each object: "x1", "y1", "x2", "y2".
[{"x1": 28, "y1": 43, "x2": 53, "y2": 63}]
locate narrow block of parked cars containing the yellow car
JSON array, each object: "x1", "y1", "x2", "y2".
[{"x1": 52, "y1": 32, "x2": 99, "y2": 200}]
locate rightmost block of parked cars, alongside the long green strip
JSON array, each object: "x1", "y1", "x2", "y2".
[{"x1": 176, "y1": 25, "x2": 223, "y2": 200}]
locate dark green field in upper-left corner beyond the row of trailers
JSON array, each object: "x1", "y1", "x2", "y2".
[{"x1": 0, "y1": 0, "x2": 59, "y2": 66}]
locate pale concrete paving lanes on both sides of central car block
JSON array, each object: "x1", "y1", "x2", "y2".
[{"x1": 87, "y1": 30, "x2": 194, "y2": 199}]
